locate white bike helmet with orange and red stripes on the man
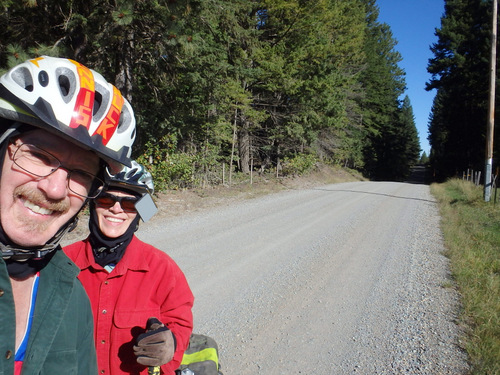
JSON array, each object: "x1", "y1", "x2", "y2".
[{"x1": 0, "y1": 56, "x2": 136, "y2": 170}]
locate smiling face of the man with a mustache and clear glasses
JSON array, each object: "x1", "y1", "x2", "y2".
[{"x1": 0, "y1": 129, "x2": 99, "y2": 247}]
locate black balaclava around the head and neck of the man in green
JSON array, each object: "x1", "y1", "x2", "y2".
[{"x1": 0, "y1": 122, "x2": 78, "y2": 279}]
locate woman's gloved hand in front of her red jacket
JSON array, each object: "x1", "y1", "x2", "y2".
[{"x1": 134, "y1": 318, "x2": 175, "y2": 366}]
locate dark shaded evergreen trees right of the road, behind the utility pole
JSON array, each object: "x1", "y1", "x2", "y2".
[{"x1": 426, "y1": 0, "x2": 500, "y2": 180}]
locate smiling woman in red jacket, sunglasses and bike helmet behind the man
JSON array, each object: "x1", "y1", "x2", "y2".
[{"x1": 64, "y1": 162, "x2": 194, "y2": 375}]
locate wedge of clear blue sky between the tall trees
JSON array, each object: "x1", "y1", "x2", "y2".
[{"x1": 377, "y1": 0, "x2": 444, "y2": 155}]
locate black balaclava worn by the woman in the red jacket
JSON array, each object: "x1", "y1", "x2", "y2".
[{"x1": 89, "y1": 187, "x2": 140, "y2": 267}]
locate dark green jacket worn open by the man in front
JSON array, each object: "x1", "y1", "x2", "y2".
[{"x1": 0, "y1": 250, "x2": 97, "y2": 375}]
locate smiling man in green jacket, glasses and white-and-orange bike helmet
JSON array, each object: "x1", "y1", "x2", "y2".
[{"x1": 0, "y1": 57, "x2": 135, "y2": 375}]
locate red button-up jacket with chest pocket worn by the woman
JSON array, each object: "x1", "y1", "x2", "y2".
[{"x1": 63, "y1": 236, "x2": 194, "y2": 375}]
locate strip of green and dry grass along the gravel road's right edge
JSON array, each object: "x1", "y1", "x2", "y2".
[{"x1": 431, "y1": 179, "x2": 500, "y2": 375}]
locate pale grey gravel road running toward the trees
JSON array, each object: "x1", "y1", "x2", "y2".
[{"x1": 138, "y1": 182, "x2": 468, "y2": 375}]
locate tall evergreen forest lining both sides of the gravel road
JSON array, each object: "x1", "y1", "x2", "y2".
[{"x1": 0, "y1": 0, "x2": 492, "y2": 189}]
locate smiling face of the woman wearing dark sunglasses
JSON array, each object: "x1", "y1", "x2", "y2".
[{"x1": 95, "y1": 190, "x2": 137, "y2": 238}]
